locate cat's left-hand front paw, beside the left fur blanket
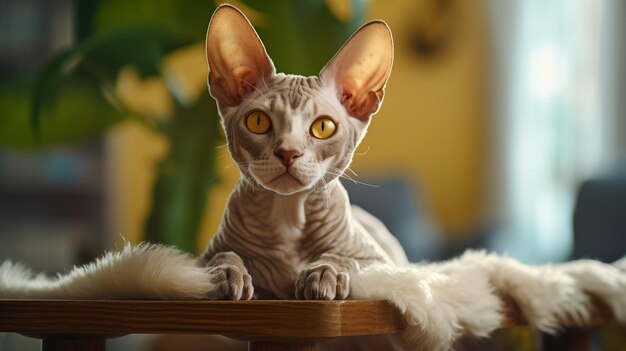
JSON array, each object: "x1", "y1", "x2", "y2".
[{"x1": 208, "y1": 264, "x2": 254, "y2": 301}]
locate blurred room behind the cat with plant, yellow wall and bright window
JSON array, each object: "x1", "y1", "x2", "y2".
[{"x1": 0, "y1": 0, "x2": 626, "y2": 350}]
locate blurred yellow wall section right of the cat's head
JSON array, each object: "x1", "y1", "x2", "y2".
[{"x1": 354, "y1": 0, "x2": 487, "y2": 236}]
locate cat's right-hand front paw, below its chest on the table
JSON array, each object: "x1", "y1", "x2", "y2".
[{"x1": 296, "y1": 264, "x2": 350, "y2": 300}]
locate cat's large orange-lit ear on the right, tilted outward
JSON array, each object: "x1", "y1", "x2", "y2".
[{"x1": 320, "y1": 21, "x2": 393, "y2": 121}]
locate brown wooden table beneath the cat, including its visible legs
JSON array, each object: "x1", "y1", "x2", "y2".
[{"x1": 0, "y1": 300, "x2": 612, "y2": 351}]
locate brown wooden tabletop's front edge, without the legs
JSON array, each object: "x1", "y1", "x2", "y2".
[{"x1": 0, "y1": 299, "x2": 403, "y2": 338}]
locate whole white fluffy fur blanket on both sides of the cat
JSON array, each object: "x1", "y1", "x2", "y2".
[{"x1": 0, "y1": 244, "x2": 626, "y2": 350}]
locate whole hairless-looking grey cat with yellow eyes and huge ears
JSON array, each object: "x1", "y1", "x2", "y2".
[{"x1": 201, "y1": 6, "x2": 408, "y2": 300}]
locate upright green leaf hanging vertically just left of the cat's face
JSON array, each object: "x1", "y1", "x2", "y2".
[{"x1": 145, "y1": 92, "x2": 221, "y2": 252}]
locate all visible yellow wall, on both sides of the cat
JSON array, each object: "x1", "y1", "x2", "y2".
[{"x1": 107, "y1": 0, "x2": 486, "y2": 250}]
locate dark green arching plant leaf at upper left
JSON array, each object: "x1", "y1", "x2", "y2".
[{"x1": 31, "y1": 26, "x2": 193, "y2": 141}]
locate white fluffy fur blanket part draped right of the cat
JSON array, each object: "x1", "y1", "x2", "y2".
[{"x1": 351, "y1": 251, "x2": 626, "y2": 350}]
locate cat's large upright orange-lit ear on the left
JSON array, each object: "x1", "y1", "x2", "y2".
[{"x1": 206, "y1": 5, "x2": 275, "y2": 106}]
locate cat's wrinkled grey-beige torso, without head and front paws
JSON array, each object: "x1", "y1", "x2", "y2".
[{"x1": 203, "y1": 180, "x2": 407, "y2": 299}]
